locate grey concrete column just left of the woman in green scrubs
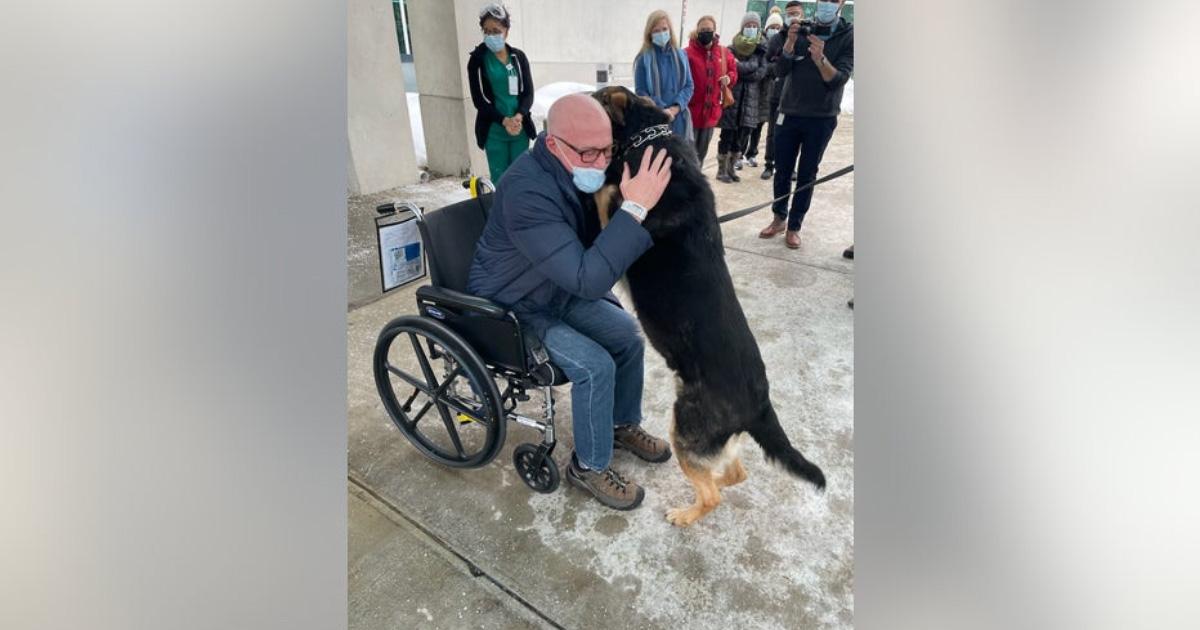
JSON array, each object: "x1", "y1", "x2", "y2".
[{"x1": 408, "y1": 0, "x2": 489, "y2": 176}]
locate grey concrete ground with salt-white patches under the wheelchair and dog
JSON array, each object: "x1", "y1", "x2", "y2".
[{"x1": 348, "y1": 116, "x2": 854, "y2": 630}]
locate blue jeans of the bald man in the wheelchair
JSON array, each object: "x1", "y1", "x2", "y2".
[{"x1": 542, "y1": 298, "x2": 646, "y2": 470}]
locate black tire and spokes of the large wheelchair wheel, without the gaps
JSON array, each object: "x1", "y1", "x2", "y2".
[{"x1": 372, "y1": 316, "x2": 508, "y2": 468}]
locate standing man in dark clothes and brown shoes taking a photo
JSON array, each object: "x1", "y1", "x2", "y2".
[{"x1": 758, "y1": 0, "x2": 854, "y2": 250}]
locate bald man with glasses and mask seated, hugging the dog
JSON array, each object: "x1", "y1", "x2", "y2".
[{"x1": 468, "y1": 94, "x2": 671, "y2": 510}]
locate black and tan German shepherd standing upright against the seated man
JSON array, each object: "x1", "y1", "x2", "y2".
[{"x1": 592, "y1": 86, "x2": 826, "y2": 527}]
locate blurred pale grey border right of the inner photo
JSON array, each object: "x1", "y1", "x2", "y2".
[{"x1": 854, "y1": 0, "x2": 1200, "y2": 629}]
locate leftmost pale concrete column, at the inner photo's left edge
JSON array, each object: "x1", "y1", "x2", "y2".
[{"x1": 346, "y1": 0, "x2": 419, "y2": 194}]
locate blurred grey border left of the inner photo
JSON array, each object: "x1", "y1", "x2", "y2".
[{"x1": 0, "y1": 0, "x2": 347, "y2": 630}]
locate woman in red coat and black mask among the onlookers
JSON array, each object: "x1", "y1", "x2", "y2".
[{"x1": 688, "y1": 16, "x2": 738, "y2": 167}]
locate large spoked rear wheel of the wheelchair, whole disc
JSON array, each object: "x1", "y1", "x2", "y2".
[{"x1": 373, "y1": 316, "x2": 506, "y2": 468}]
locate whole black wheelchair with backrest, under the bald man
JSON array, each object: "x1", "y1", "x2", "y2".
[{"x1": 372, "y1": 180, "x2": 568, "y2": 493}]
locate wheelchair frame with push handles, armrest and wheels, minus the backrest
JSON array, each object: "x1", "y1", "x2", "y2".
[{"x1": 372, "y1": 184, "x2": 566, "y2": 493}]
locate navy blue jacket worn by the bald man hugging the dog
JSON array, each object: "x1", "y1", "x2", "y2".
[{"x1": 467, "y1": 133, "x2": 653, "y2": 336}]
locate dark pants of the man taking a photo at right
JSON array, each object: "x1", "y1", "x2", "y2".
[{"x1": 770, "y1": 116, "x2": 838, "y2": 232}]
